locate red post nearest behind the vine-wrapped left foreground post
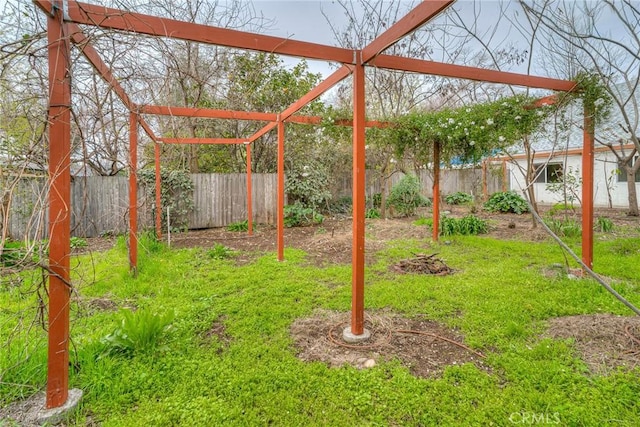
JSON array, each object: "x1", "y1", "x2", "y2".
[{"x1": 129, "y1": 112, "x2": 138, "y2": 276}]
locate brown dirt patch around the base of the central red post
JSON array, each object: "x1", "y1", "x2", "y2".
[{"x1": 291, "y1": 311, "x2": 486, "y2": 378}]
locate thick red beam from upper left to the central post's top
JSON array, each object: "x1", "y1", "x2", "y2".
[{"x1": 65, "y1": 0, "x2": 354, "y2": 63}]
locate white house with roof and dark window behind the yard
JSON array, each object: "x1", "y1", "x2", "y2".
[{"x1": 496, "y1": 85, "x2": 640, "y2": 208}]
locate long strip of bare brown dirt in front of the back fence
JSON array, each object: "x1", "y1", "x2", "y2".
[{"x1": 87, "y1": 204, "x2": 640, "y2": 266}]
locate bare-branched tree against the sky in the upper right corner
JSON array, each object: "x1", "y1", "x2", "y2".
[{"x1": 522, "y1": 0, "x2": 640, "y2": 216}]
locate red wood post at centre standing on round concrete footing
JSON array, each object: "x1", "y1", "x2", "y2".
[{"x1": 351, "y1": 58, "x2": 365, "y2": 335}]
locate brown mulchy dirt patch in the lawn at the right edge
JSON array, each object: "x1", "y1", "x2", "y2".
[{"x1": 545, "y1": 314, "x2": 640, "y2": 374}]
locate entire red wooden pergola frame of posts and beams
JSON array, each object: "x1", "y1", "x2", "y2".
[{"x1": 34, "y1": 0, "x2": 594, "y2": 408}]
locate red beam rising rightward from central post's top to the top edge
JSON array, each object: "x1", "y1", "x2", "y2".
[{"x1": 362, "y1": 0, "x2": 455, "y2": 64}]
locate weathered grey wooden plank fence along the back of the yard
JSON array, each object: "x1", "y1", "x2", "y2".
[{"x1": 7, "y1": 169, "x2": 502, "y2": 239}]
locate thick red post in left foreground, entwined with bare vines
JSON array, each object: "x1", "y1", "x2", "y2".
[{"x1": 46, "y1": 0, "x2": 71, "y2": 408}]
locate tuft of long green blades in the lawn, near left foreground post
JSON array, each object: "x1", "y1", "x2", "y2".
[{"x1": 102, "y1": 309, "x2": 175, "y2": 356}]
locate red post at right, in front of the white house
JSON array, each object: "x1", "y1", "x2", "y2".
[{"x1": 582, "y1": 103, "x2": 594, "y2": 268}]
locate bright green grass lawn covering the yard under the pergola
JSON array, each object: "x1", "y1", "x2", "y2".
[{"x1": 0, "y1": 226, "x2": 640, "y2": 426}]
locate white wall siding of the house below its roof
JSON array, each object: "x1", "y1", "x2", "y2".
[{"x1": 507, "y1": 150, "x2": 640, "y2": 208}]
